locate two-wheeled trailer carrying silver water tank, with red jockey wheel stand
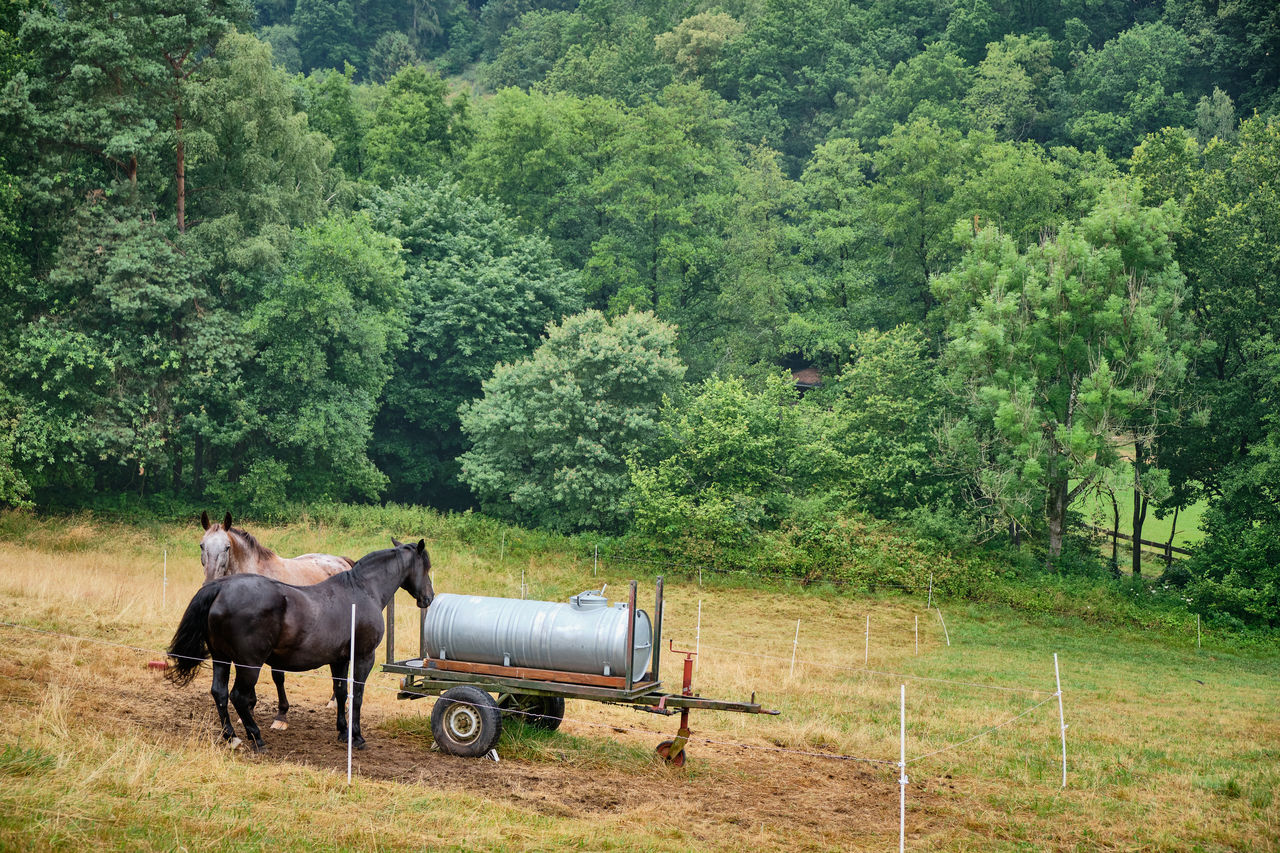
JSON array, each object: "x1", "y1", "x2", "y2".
[{"x1": 383, "y1": 578, "x2": 778, "y2": 767}]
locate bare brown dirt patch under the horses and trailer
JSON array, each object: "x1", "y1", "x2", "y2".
[{"x1": 74, "y1": 650, "x2": 920, "y2": 849}]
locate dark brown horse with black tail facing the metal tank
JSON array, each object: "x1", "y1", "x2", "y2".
[{"x1": 165, "y1": 539, "x2": 435, "y2": 749}]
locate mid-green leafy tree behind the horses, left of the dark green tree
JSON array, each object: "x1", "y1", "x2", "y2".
[{"x1": 215, "y1": 215, "x2": 404, "y2": 508}]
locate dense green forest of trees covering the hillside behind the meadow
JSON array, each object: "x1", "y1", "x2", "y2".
[{"x1": 0, "y1": 0, "x2": 1280, "y2": 625}]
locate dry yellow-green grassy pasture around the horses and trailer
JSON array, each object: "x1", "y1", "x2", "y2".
[{"x1": 0, "y1": 514, "x2": 1280, "y2": 852}]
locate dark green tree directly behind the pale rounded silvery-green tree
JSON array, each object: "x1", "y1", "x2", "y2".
[{"x1": 370, "y1": 182, "x2": 582, "y2": 507}]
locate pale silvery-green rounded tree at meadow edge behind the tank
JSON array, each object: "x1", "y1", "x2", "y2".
[{"x1": 461, "y1": 311, "x2": 685, "y2": 530}]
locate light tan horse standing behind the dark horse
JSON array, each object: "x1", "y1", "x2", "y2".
[{"x1": 200, "y1": 512, "x2": 353, "y2": 730}]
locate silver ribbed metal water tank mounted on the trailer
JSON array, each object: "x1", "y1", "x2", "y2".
[{"x1": 422, "y1": 589, "x2": 653, "y2": 681}]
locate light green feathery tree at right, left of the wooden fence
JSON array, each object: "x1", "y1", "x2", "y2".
[{"x1": 933, "y1": 187, "x2": 1189, "y2": 565}]
